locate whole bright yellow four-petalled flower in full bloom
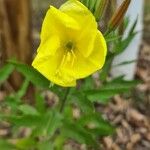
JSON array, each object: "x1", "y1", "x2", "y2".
[{"x1": 32, "y1": 0, "x2": 107, "y2": 87}]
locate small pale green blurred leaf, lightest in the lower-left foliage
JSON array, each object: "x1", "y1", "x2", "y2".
[{"x1": 18, "y1": 104, "x2": 39, "y2": 116}]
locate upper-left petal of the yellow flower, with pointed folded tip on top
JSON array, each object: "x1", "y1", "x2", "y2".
[{"x1": 41, "y1": 6, "x2": 79, "y2": 41}]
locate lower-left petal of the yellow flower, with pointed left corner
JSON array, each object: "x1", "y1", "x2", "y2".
[{"x1": 32, "y1": 49, "x2": 76, "y2": 87}]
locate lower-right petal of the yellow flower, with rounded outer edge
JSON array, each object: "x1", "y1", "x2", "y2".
[{"x1": 64, "y1": 31, "x2": 107, "y2": 79}]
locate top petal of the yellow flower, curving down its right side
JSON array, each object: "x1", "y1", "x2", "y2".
[{"x1": 60, "y1": 0, "x2": 97, "y2": 57}]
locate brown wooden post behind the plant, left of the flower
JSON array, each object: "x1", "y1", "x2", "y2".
[{"x1": 0, "y1": 0, "x2": 32, "y2": 89}]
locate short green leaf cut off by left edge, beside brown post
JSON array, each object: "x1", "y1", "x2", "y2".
[{"x1": 0, "y1": 64, "x2": 14, "y2": 83}]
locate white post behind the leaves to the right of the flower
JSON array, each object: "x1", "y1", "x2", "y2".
[{"x1": 111, "y1": 0, "x2": 144, "y2": 80}]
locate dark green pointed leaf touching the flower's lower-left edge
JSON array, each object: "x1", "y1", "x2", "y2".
[{"x1": 9, "y1": 61, "x2": 50, "y2": 88}]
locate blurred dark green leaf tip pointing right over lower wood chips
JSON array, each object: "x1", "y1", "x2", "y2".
[{"x1": 78, "y1": 113, "x2": 115, "y2": 137}]
